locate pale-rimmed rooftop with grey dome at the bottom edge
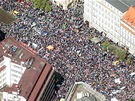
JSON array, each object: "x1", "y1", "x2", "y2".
[{"x1": 66, "y1": 82, "x2": 106, "y2": 101}]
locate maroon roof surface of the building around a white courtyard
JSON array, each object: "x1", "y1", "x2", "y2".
[{"x1": 0, "y1": 37, "x2": 52, "y2": 101}]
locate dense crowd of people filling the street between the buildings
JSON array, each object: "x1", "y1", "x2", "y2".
[{"x1": 0, "y1": 0, "x2": 135, "y2": 101}]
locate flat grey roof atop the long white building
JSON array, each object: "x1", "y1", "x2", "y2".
[{"x1": 106, "y1": 0, "x2": 135, "y2": 13}]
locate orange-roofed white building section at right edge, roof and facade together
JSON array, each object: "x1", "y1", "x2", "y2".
[{"x1": 120, "y1": 6, "x2": 135, "y2": 55}]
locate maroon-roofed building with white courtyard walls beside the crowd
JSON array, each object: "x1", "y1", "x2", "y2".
[{"x1": 0, "y1": 37, "x2": 55, "y2": 101}]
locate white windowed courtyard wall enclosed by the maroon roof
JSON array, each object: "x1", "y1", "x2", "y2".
[{"x1": 0, "y1": 56, "x2": 26, "y2": 88}]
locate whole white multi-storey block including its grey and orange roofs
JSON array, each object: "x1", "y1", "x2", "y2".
[{"x1": 83, "y1": 0, "x2": 135, "y2": 55}]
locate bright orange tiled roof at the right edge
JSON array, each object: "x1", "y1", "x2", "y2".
[{"x1": 122, "y1": 6, "x2": 135, "y2": 28}]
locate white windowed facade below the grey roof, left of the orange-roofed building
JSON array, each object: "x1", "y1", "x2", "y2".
[{"x1": 84, "y1": 0, "x2": 122, "y2": 43}]
